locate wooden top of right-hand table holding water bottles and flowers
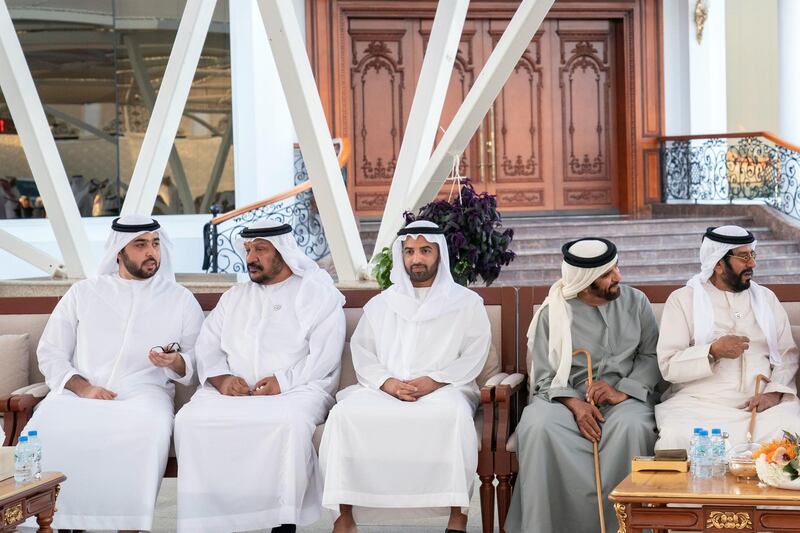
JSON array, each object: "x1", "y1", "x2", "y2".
[{"x1": 609, "y1": 472, "x2": 800, "y2": 506}]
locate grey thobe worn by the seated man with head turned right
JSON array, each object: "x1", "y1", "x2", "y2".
[{"x1": 505, "y1": 285, "x2": 661, "y2": 533}]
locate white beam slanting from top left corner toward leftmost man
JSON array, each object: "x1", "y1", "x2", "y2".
[{"x1": 0, "y1": 2, "x2": 95, "y2": 277}]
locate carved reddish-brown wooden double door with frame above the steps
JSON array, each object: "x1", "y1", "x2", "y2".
[{"x1": 307, "y1": 0, "x2": 663, "y2": 217}]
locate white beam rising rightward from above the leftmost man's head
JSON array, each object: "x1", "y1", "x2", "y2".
[{"x1": 122, "y1": 0, "x2": 217, "y2": 215}]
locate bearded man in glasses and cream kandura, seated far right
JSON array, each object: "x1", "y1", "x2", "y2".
[{"x1": 656, "y1": 226, "x2": 800, "y2": 449}]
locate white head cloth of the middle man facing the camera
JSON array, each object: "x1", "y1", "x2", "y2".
[{"x1": 384, "y1": 220, "x2": 480, "y2": 322}]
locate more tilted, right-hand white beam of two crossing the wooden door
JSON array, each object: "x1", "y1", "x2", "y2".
[{"x1": 406, "y1": 0, "x2": 555, "y2": 212}]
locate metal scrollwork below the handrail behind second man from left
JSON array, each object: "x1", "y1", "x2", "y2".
[{"x1": 207, "y1": 149, "x2": 329, "y2": 273}]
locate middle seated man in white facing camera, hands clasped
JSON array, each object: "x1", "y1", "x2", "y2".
[{"x1": 320, "y1": 221, "x2": 491, "y2": 532}]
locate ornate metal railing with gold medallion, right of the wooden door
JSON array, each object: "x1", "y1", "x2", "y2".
[{"x1": 661, "y1": 132, "x2": 800, "y2": 219}]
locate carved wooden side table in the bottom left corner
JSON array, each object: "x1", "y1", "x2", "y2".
[{"x1": 0, "y1": 472, "x2": 67, "y2": 533}]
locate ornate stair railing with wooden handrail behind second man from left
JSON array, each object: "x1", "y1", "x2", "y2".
[{"x1": 203, "y1": 139, "x2": 350, "y2": 273}]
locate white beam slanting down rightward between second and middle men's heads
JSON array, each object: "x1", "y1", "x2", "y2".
[{"x1": 258, "y1": 0, "x2": 367, "y2": 281}]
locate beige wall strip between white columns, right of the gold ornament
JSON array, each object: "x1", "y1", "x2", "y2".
[{"x1": 728, "y1": 0, "x2": 778, "y2": 133}]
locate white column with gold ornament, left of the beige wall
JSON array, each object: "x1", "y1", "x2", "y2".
[{"x1": 683, "y1": 0, "x2": 728, "y2": 135}]
